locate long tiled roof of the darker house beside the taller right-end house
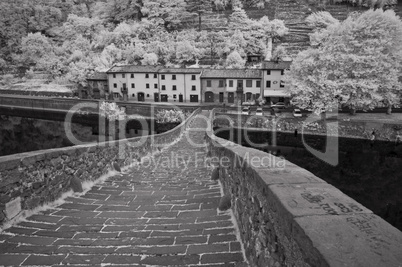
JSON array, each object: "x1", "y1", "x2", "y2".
[{"x1": 201, "y1": 69, "x2": 261, "y2": 79}]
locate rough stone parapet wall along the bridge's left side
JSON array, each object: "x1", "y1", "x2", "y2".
[{"x1": 0, "y1": 109, "x2": 200, "y2": 224}]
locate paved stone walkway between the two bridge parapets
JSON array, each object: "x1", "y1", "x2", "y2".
[{"x1": 0, "y1": 112, "x2": 247, "y2": 266}]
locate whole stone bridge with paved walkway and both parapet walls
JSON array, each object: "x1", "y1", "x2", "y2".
[{"x1": 0, "y1": 109, "x2": 402, "y2": 267}]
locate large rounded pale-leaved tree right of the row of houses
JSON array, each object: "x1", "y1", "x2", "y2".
[{"x1": 286, "y1": 9, "x2": 402, "y2": 114}]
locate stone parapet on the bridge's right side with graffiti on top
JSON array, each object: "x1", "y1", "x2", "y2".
[{"x1": 206, "y1": 109, "x2": 402, "y2": 266}]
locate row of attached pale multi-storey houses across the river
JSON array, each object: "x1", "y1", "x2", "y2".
[{"x1": 98, "y1": 61, "x2": 291, "y2": 105}]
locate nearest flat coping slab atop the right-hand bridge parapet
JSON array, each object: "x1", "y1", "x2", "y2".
[{"x1": 293, "y1": 214, "x2": 402, "y2": 267}]
